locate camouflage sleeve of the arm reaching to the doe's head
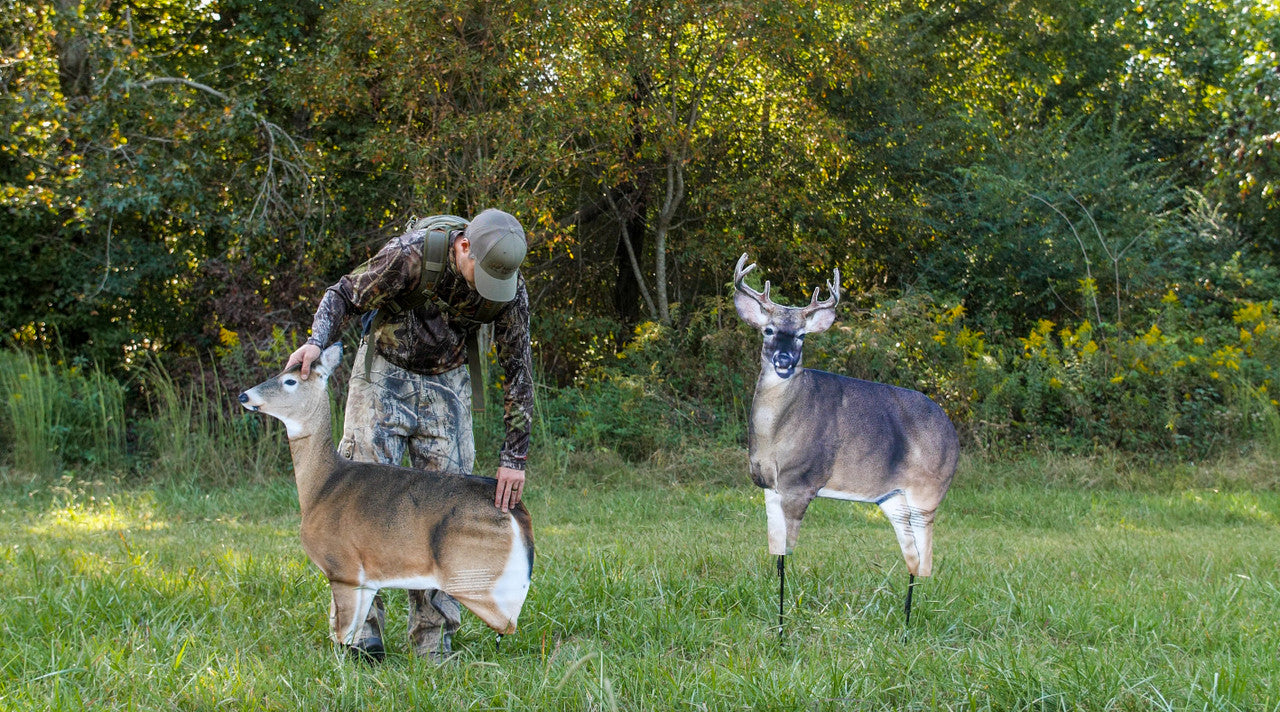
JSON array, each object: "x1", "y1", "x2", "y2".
[{"x1": 307, "y1": 231, "x2": 426, "y2": 348}]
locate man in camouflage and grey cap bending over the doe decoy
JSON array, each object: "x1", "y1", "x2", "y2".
[{"x1": 287, "y1": 210, "x2": 534, "y2": 661}]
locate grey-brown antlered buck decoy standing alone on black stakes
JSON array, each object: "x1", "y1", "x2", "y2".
[{"x1": 733, "y1": 255, "x2": 960, "y2": 627}]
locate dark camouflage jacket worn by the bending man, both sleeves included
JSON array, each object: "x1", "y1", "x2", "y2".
[{"x1": 307, "y1": 229, "x2": 534, "y2": 470}]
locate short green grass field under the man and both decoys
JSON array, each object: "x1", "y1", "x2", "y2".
[{"x1": 0, "y1": 453, "x2": 1280, "y2": 711}]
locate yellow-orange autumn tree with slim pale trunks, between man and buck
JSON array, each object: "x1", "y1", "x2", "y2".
[{"x1": 555, "y1": 0, "x2": 841, "y2": 324}]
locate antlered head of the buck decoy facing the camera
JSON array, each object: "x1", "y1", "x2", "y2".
[{"x1": 733, "y1": 252, "x2": 840, "y2": 379}]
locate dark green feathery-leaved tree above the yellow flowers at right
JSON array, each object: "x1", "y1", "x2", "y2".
[{"x1": 924, "y1": 119, "x2": 1178, "y2": 332}]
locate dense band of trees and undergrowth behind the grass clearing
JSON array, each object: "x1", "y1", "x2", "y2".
[{"x1": 0, "y1": 0, "x2": 1280, "y2": 479}]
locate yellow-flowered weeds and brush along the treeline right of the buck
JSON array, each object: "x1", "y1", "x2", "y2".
[{"x1": 806, "y1": 292, "x2": 1280, "y2": 458}]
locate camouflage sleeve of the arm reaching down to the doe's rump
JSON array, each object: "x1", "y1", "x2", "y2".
[{"x1": 493, "y1": 279, "x2": 534, "y2": 470}]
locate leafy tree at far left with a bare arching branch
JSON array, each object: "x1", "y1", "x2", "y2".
[{"x1": 0, "y1": 0, "x2": 325, "y2": 362}]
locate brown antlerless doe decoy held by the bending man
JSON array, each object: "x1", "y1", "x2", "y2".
[{"x1": 239, "y1": 344, "x2": 534, "y2": 645}]
